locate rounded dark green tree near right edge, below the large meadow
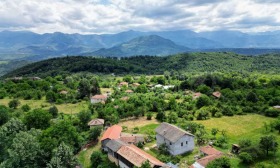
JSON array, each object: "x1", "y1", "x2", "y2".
[{"x1": 259, "y1": 135, "x2": 278, "y2": 155}]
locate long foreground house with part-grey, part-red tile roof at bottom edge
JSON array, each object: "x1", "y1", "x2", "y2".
[{"x1": 106, "y1": 140, "x2": 165, "y2": 168}]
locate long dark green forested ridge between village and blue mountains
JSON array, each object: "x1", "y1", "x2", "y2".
[{"x1": 4, "y1": 52, "x2": 280, "y2": 78}]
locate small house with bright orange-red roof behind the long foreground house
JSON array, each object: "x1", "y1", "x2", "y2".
[{"x1": 101, "y1": 125, "x2": 122, "y2": 151}]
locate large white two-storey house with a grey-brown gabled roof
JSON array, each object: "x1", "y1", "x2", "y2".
[{"x1": 156, "y1": 122, "x2": 195, "y2": 155}]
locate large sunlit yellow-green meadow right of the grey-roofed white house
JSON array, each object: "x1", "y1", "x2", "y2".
[{"x1": 195, "y1": 114, "x2": 280, "y2": 168}]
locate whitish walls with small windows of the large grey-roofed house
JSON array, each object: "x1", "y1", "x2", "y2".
[{"x1": 156, "y1": 134, "x2": 194, "y2": 155}]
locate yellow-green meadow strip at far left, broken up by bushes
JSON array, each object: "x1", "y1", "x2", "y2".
[{"x1": 0, "y1": 98, "x2": 88, "y2": 114}]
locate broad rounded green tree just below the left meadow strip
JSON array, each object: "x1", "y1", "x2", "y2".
[{"x1": 24, "y1": 109, "x2": 52, "y2": 129}]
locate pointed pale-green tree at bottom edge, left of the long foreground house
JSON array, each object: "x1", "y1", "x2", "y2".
[{"x1": 47, "y1": 142, "x2": 78, "y2": 168}]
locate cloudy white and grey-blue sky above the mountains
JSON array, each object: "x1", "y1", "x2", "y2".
[{"x1": 0, "y1": 0, "x2": 280, "y2": 34}]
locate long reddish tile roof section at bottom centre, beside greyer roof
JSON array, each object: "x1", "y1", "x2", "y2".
[{"x1": 117, "y1": 145, "x2": 164, "y2": 167}]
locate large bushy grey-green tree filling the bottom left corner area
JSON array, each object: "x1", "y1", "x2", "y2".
[{"x1": 4, "y1": 130, "x2": 41, "y2": 167}]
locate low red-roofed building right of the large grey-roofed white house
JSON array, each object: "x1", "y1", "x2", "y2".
[{"x1": 190, "y1": 146, "x2": 223, "y2": 168}]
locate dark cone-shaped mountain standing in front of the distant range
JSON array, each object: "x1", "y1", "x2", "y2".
[{"x1": 85, "y1": 35, "x2": 188, "y2": 57}]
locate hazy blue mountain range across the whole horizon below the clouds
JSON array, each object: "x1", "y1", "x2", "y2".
[{"x1": 0, "y1": 30, "x2": 280, "y2": 60}]
